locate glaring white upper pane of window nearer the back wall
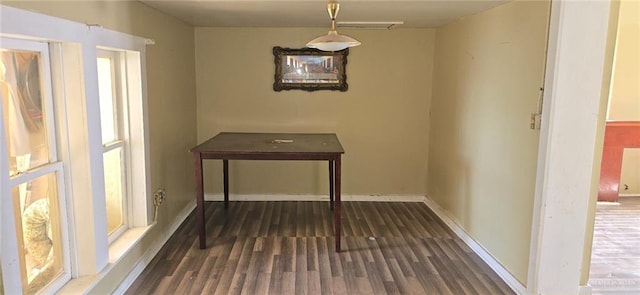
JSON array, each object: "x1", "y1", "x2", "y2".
[{"x1": 98, "y1": 57, "x2": 118, "y2": 144}]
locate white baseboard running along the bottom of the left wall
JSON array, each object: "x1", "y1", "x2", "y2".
[{"x1": 113, "y1": 200, "x2": 196, "y2": 294}]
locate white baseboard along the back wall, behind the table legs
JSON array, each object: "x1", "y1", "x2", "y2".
[{"x1": 204, "y1": 194, "x2": 424, "y2": 202}]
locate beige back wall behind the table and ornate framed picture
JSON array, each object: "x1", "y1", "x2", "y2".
[{"x1": 195, "y1": 28, "x2": 434, "y2": 195}]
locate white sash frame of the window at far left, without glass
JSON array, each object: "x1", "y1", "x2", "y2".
[{"x1": 0, "y1": 36, "x2": 71, "y2": 294}]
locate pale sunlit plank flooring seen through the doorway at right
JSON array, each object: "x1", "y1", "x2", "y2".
[{"x1": 589, "y1": 197, "x2": 640, "y2": 294}]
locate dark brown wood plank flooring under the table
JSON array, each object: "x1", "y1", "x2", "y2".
[{"x1": 126, "y1": 201, "x2": 514, "y2": 295}]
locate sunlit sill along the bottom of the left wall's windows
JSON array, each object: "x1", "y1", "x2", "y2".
[{"x1": 57, "y1": 222, "x2": 156, "y2": 294}]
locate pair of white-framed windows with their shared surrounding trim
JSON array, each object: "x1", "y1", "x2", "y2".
[{"x1": 0, "y1": 6, "x2": 153, "y2": 294}]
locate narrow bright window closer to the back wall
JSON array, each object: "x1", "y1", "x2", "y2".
[{"x1": 97, "y1": 50, "x2": 129, "y2": 241}]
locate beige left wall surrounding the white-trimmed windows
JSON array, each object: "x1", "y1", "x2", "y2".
[{"x1": 2, "y1": 1, "x2": 196, "y2": 293}]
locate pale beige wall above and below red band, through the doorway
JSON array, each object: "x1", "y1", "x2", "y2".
[{"x1": 607, "y1": 0, "x2": 640, "y2": 194}]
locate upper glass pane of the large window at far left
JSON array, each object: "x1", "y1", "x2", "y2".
[{"x1": 0, "y1": 50, "x2": 50, "y2": 176}]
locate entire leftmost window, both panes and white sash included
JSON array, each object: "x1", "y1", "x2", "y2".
[{"x1": 0, "y1": 38, "x2": 70, "y2": 294}]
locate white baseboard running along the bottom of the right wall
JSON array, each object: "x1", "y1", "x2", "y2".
[{"x1": 423, "y1": 196, "x2": 527, "y2": 294}]
